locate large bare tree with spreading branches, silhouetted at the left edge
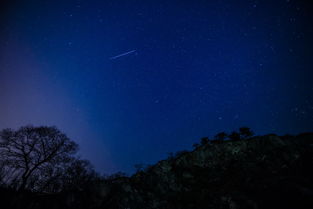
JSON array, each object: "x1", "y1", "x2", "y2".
[{"x1": 0, "y1": 126, "x2": 78, "y2": 190}]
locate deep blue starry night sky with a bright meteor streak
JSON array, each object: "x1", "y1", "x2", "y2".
[{"x1": 0, "y1": 0, "x2": 313, "y2": 173}]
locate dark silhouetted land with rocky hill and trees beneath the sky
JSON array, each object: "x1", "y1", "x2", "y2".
[{"x1": 0, "y1": 127, "x2": 313, "y2": 209}]
